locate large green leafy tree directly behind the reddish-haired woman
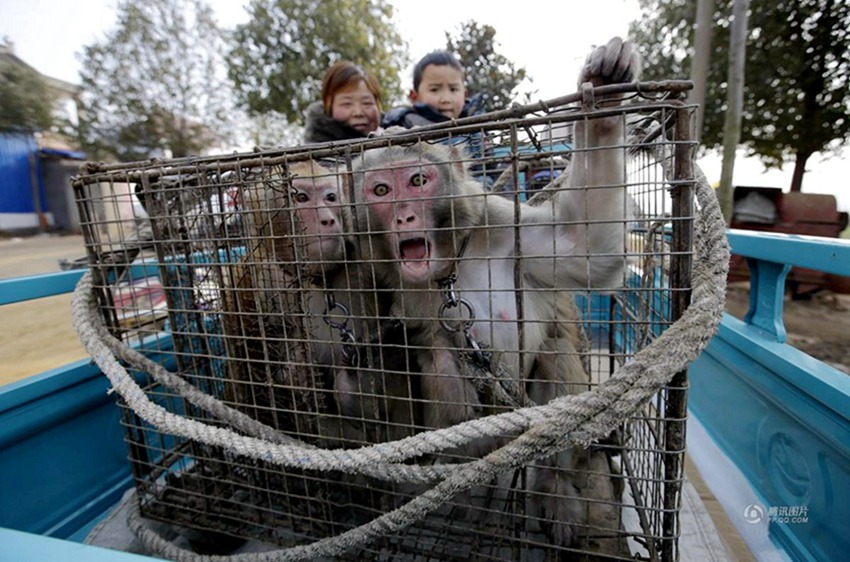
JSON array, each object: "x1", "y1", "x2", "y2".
[{"x1": 228, "y1": 0, "x2": 408, "y2": 123}]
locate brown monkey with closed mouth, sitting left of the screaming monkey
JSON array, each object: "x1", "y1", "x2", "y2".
[{"x1": 219, "y1": 161, "x2": 417, "y2": 447}]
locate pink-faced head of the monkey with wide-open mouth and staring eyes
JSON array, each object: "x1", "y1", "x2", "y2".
[{"x1": 354, "y1": 142, "x2": 484, "y2": 287}]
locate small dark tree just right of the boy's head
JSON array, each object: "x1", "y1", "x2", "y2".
[{"x1": 446, "y1": 20, "x2": 531, "y2": 111}]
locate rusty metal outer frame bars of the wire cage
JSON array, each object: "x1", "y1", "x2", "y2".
[{"x1": 74, "y1": 82, "x2": 695, "y2": 560}]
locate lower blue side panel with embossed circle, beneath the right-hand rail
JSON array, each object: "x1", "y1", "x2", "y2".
[{"x1": 689, "y1": 317, "x2": 850, "y2": 562}]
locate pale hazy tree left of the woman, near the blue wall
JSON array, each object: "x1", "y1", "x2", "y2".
[{"x1": 78, "y1": 0, "x2": 232, "y2": 161}]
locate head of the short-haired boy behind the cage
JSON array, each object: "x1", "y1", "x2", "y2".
[{"x1": 410, "y1": 51, "x2": 466, "y2": 119}]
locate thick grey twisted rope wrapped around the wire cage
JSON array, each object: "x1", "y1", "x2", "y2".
[{"x1": 72, "y1": 168, "x2": 729, "y2": 562}]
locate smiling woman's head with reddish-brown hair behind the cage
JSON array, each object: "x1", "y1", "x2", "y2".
[{"x1": 322, "y1": 61, "x2": 381, "y2": 133}]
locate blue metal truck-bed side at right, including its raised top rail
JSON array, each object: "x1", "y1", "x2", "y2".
[{"x1": 689, "y1": 231, "x2": 850, "y2": 561}]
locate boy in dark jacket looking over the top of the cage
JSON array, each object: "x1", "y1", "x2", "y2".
[{"x1": 381, "y1": 51, "x2": 481, "y2": 129}]
